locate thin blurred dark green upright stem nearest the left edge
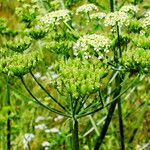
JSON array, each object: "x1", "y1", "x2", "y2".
[{"x1": 7, "y1": 79, "x2": 11, "y2": 150}]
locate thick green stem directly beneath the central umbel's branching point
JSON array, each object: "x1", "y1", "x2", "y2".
[{"x1": 72, "y1": 118, "x2": 79, "y2": 150}]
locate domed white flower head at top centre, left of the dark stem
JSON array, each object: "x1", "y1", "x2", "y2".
[{"x1": 76, "y1": 4, "x2": 98, "y2": 15}]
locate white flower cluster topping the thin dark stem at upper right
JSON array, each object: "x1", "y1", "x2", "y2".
[{"x1": 104, "y1": 11, "x2": 129, "y2": 27}]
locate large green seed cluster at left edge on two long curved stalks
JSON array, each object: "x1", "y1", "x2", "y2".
[{"x1": 0, "y1": 51, "x2": 41, "y2": 76}]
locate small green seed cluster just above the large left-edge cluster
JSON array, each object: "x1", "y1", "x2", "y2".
[{"x1": 6, "y1": 36, "x2": 31, "y2": 52}]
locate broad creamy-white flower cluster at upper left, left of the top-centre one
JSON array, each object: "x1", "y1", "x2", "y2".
[{"x1": 39, "y1": 9, "x2": 71, "y2": 26}]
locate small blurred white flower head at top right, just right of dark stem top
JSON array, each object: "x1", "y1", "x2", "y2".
[{"x1": 120, "y1": 5, "x2": 139, "y2": 13}]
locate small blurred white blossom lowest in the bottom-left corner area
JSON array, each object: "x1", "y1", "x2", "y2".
[{"x1": 23, "y1": 133, "x2": 34, "y2": 150}]
